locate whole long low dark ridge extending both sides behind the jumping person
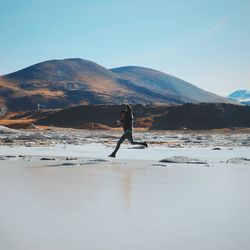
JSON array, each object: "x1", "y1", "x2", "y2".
[{"x1": 36, "y1": 103, "x2": 250, "y2": 130}]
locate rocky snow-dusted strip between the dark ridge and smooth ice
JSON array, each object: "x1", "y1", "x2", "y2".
[{"x1": 0, "y1": 125, "x2": 250, "y2": 148}]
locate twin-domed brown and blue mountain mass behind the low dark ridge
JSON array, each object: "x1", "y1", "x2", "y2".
[{"x1": 0, "y1": 58, "x2": 234, "y2": 111}]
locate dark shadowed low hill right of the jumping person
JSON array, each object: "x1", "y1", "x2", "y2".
[{"x1": 151, "y1": 103, "x2": 250, "y2": 130}]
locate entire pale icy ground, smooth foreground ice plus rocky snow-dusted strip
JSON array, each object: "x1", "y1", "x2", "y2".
[{"x1": 0, "y1": 127, "x2": 250, "y2": 250}]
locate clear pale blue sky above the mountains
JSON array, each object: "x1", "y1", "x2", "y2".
[{"x1": 0, "y1": 0, "x2": 250, "y2": 96}]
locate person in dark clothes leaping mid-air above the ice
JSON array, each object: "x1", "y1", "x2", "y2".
[{"x1": 109, "y1": 104, "x2": 148, "y2": 158}]
